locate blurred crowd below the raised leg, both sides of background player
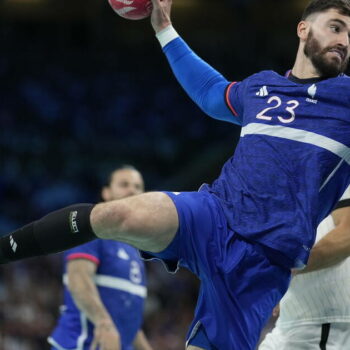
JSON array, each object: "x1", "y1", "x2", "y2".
[{"x1": 0, "y1": 254, "x2": 198, "y2": 350}]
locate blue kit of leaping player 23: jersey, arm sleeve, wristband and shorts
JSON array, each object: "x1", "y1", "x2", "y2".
[{"x1": 141, "y1": 32, "x2": 350, "y2": 350}]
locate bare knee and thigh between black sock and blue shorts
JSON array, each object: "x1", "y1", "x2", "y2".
[{"x1": 91, "y1": 192, "x2": 179, "y2": 252}]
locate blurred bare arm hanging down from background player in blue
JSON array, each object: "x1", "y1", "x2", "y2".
[{"x1": 67, "y1": 259, "x2": 121, "y2": 350}]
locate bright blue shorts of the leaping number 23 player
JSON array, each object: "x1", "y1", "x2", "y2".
[{"x1": 142, "y1": 191, "x2": 290, "y2": 350}]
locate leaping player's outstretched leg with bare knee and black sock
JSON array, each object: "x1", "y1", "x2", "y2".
[{"x1": 0, "y1": 192, "x2": 178, "y2": 263}]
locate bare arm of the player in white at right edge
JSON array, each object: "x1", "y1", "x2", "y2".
[{"x1": 297, "y1": 207, "x2": 350, "y2": 274}]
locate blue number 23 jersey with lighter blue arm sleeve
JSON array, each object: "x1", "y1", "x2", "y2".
[{"x1": 164, "y1": 38, "x2": 350, "y2": 267}]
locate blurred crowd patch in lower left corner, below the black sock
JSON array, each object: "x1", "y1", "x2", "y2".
[{"x1": 0, "y1": 256, "x2": 61, "y2": 350}]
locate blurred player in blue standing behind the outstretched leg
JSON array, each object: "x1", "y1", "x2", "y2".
[{"x1": 48, "y1": 165, "x2": 152, "y2": 350}]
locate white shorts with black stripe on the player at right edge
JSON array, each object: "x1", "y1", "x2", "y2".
[{"x1": 259, "y1": 322, "x2": 350, "y2": 350}]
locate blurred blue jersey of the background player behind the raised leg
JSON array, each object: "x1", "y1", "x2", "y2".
[{"x1": 49, "y1": 239, "x2": 147, "y2": 350}]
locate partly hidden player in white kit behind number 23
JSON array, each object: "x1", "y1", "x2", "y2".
[{"x1": 259, "y1": 187, "x2": 350, "y2": 350}]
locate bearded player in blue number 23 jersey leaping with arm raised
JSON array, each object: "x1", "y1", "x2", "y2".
[{"x1": 0, "y1": 0, "x2": 350, "y2": 350}]
